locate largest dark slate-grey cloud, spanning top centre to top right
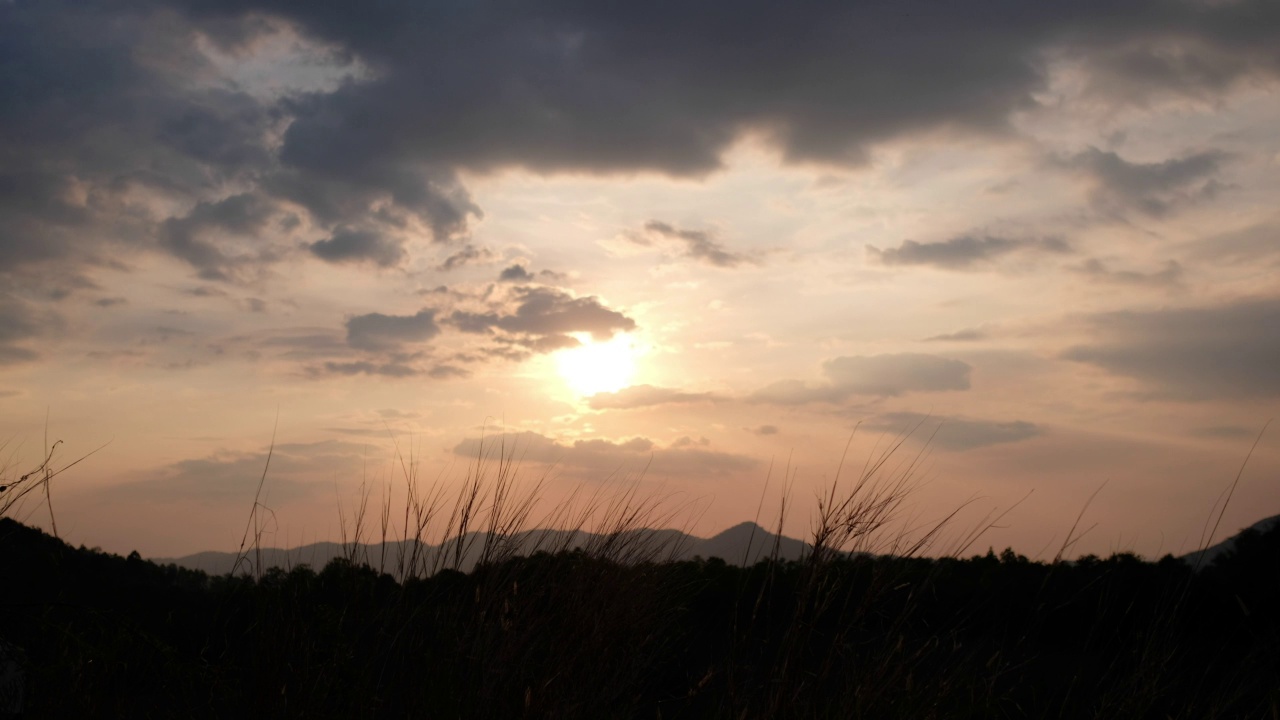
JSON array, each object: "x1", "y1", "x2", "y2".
[{"x1": 177, "y1": 0, "x2": 1280, "y2": 174}]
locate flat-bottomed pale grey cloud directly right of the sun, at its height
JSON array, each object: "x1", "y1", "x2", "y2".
[{"x1": 750, "y1": 352, "x2": 972, "y2": 405}]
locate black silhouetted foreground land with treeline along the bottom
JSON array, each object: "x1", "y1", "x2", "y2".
[{"x1": 0, "y1": 519, "x2": 1280, "y2": 719}]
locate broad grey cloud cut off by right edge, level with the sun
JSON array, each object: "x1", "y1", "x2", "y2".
[{"x1": 1062, "y1": 297, "x2": 1280, "y2": 400}]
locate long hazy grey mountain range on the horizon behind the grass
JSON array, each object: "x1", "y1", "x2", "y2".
[{"x1": 152, "y1": 523, "x2": 810, "y2": 575}]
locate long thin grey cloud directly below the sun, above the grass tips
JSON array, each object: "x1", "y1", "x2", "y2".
[{"x1": 453, "y1": 430, "x2": 760, "y2": 480}]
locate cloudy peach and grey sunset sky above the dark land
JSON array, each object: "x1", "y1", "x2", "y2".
[{"x1": 0, "y1": 0, "x2": 1280, "y2": 559}]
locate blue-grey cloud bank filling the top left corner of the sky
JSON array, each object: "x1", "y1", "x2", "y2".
[{"x1": 0, "y1": 3, "x2": 271, "y2": 278}]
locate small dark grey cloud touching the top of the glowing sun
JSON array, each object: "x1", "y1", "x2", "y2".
[{"x1": 448, "y1": 287, "x2": 636, "y2": 351}]
